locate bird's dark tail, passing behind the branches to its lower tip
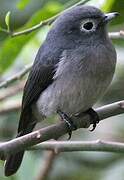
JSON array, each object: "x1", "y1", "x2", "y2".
[{"x1": 4, "y1": 109, "x2": 36, "y2": 176}]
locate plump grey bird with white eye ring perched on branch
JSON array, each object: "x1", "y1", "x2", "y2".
[{"x1": 4, "y1": 5, "x2": 118, "y2": 176}]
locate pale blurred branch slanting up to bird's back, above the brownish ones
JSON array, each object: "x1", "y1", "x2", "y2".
[{"x1": 0, "y1": 65, "x2": 32, "y2": 88}]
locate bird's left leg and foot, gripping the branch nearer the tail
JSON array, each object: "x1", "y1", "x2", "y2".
[{"x1": 57, "y1": 110, "x2": 77, "y2": 140}]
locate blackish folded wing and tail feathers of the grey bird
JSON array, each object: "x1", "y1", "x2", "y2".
[{"x1": 5, "y1": 60, "x2": 54, "y2": 176}]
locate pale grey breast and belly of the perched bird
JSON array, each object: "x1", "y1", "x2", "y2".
[{"x1": 33, "y1": 45, "x2": 116, "y2": 119}]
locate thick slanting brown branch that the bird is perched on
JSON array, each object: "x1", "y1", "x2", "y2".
[{"x1": 0, "y1": 101, "x2": 124, "y2": 158}]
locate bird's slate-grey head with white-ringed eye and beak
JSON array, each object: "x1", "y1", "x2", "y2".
[{"x1": 50, "y1": 6, "x2": 118, "y2": 42}]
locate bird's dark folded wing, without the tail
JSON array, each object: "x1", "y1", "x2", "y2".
[{"x1": 22, "y1": 63, "x2": 55, "y2": 110}]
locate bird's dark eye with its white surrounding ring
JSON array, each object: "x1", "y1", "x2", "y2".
[{"x1": 80, "y1": 19, "x2": 96, "y2": 32}]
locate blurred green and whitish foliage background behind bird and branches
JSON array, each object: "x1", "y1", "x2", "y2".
[{"x1": 0, "y1": 0, "x2": 124, "y2": 180}]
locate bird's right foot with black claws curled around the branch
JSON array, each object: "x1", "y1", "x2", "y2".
[{"x1": 85, "y1": 108, "x2": 99, "y2": 131}]
